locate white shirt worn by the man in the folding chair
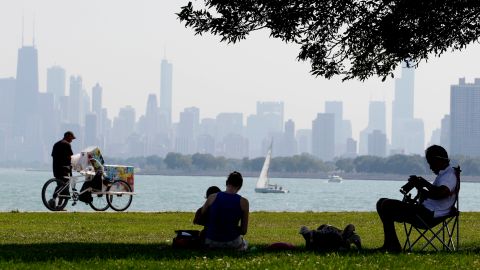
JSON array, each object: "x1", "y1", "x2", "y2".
[{"x1": 423, "y1": 167, "x2": 457, "y2": 217}]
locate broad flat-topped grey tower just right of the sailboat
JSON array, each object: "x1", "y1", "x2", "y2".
[{"x1": 312, "y1": 113, "x2": 335, "y2": 161}]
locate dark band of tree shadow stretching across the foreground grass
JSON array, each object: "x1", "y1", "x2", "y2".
[{"x1": 0, "y1": 243, "x2": 480, "y2": 262}]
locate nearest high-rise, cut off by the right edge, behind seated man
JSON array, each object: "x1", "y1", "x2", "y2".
[{"x1": 450, "y1": 78, "x2": 480, "y2": 157}]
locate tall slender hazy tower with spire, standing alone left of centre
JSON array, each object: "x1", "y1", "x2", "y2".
[{"x1": 160, "y1": 59, "x2": 173, "y2": 128}]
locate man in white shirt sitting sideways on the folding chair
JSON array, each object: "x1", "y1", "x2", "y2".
[{"x1": 377, "y1": 145, "x2": 457, "y2": 252}]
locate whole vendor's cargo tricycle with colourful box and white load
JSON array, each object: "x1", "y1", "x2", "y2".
[{"x1": 42, "y1": 147, "x2": 135, "y2": 211}]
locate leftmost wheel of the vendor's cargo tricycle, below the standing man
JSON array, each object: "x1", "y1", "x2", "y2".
[{"x1": 42, "y1": 178, "x2": 70, "y2": 211}]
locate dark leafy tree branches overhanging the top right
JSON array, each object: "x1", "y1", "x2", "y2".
[{"x1": 177, "y1": 0, "x2": 480, "y2": 80}]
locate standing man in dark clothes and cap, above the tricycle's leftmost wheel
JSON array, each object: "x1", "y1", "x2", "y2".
[{"x1": 52, "y1": 131, "x2": 75, "y2": 180}]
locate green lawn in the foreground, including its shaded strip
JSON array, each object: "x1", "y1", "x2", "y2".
[{"x1": 0, "y1": 212, "x2": 480, "y2": 269}]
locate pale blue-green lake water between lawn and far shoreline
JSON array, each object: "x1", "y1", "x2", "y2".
[{"x1": 0, "y1": 169, "x2": 480, "y2": 212}]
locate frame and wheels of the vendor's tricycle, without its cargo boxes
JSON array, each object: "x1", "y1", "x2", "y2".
[{"x1": 41, "y1": 160, "x2": 134, "y2": 211}]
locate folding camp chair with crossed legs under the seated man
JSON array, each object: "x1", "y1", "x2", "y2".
[{"x1": 403, "y1": 166, "x2": 461, "y2": 251}]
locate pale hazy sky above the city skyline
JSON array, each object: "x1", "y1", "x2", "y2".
[{"x1": 0, "y1": 0, "x2": 480, "y2": 142}]
